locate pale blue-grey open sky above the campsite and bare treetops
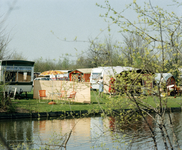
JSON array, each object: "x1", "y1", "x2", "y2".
[{"x1": 0, "y1": 0, "x2": 181, "y2": 60}]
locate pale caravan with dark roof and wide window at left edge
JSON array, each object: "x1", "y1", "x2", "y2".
[{"x1": 0, "y1": 60, "x2": 34, "y2": 94}]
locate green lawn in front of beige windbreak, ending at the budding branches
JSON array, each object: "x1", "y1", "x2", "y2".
[{"x1": 12, "y1": 91, "x2": 108, "y2": 112}]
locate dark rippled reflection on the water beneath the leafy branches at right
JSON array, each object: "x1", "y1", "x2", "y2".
[{"x1": 109, "y1": 114, "x2": 155, "y2": 149}]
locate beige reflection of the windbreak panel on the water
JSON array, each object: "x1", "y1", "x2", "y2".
[{"x1": 33, "y1": 118, "x2": 91, "y2": 146}]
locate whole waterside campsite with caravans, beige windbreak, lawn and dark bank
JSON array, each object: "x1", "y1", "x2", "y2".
[{"x1": 0, "y1": 60, "x2": 182, "y2": 149}]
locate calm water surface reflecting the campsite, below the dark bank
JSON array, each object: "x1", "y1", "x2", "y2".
[{"x1": 0, "y1": 112, "x2": 182, "y2": 150}]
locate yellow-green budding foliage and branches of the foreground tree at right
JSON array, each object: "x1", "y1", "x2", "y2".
[{"x1": 94, "y1": 0, "x2": 182, "y2": 149}]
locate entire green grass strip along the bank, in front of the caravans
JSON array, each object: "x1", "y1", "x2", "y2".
[{"x1": 12, "y1": 91, "x2": 182, "y2": 112}]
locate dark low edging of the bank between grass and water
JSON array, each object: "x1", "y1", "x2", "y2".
[{"x1": 0, "y1": 107, "x2": 182, "y2": 119}]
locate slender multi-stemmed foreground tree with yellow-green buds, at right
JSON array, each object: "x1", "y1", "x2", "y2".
[{"x1": 97, "y1": 0, "x2": 181, "y2": 149}]
